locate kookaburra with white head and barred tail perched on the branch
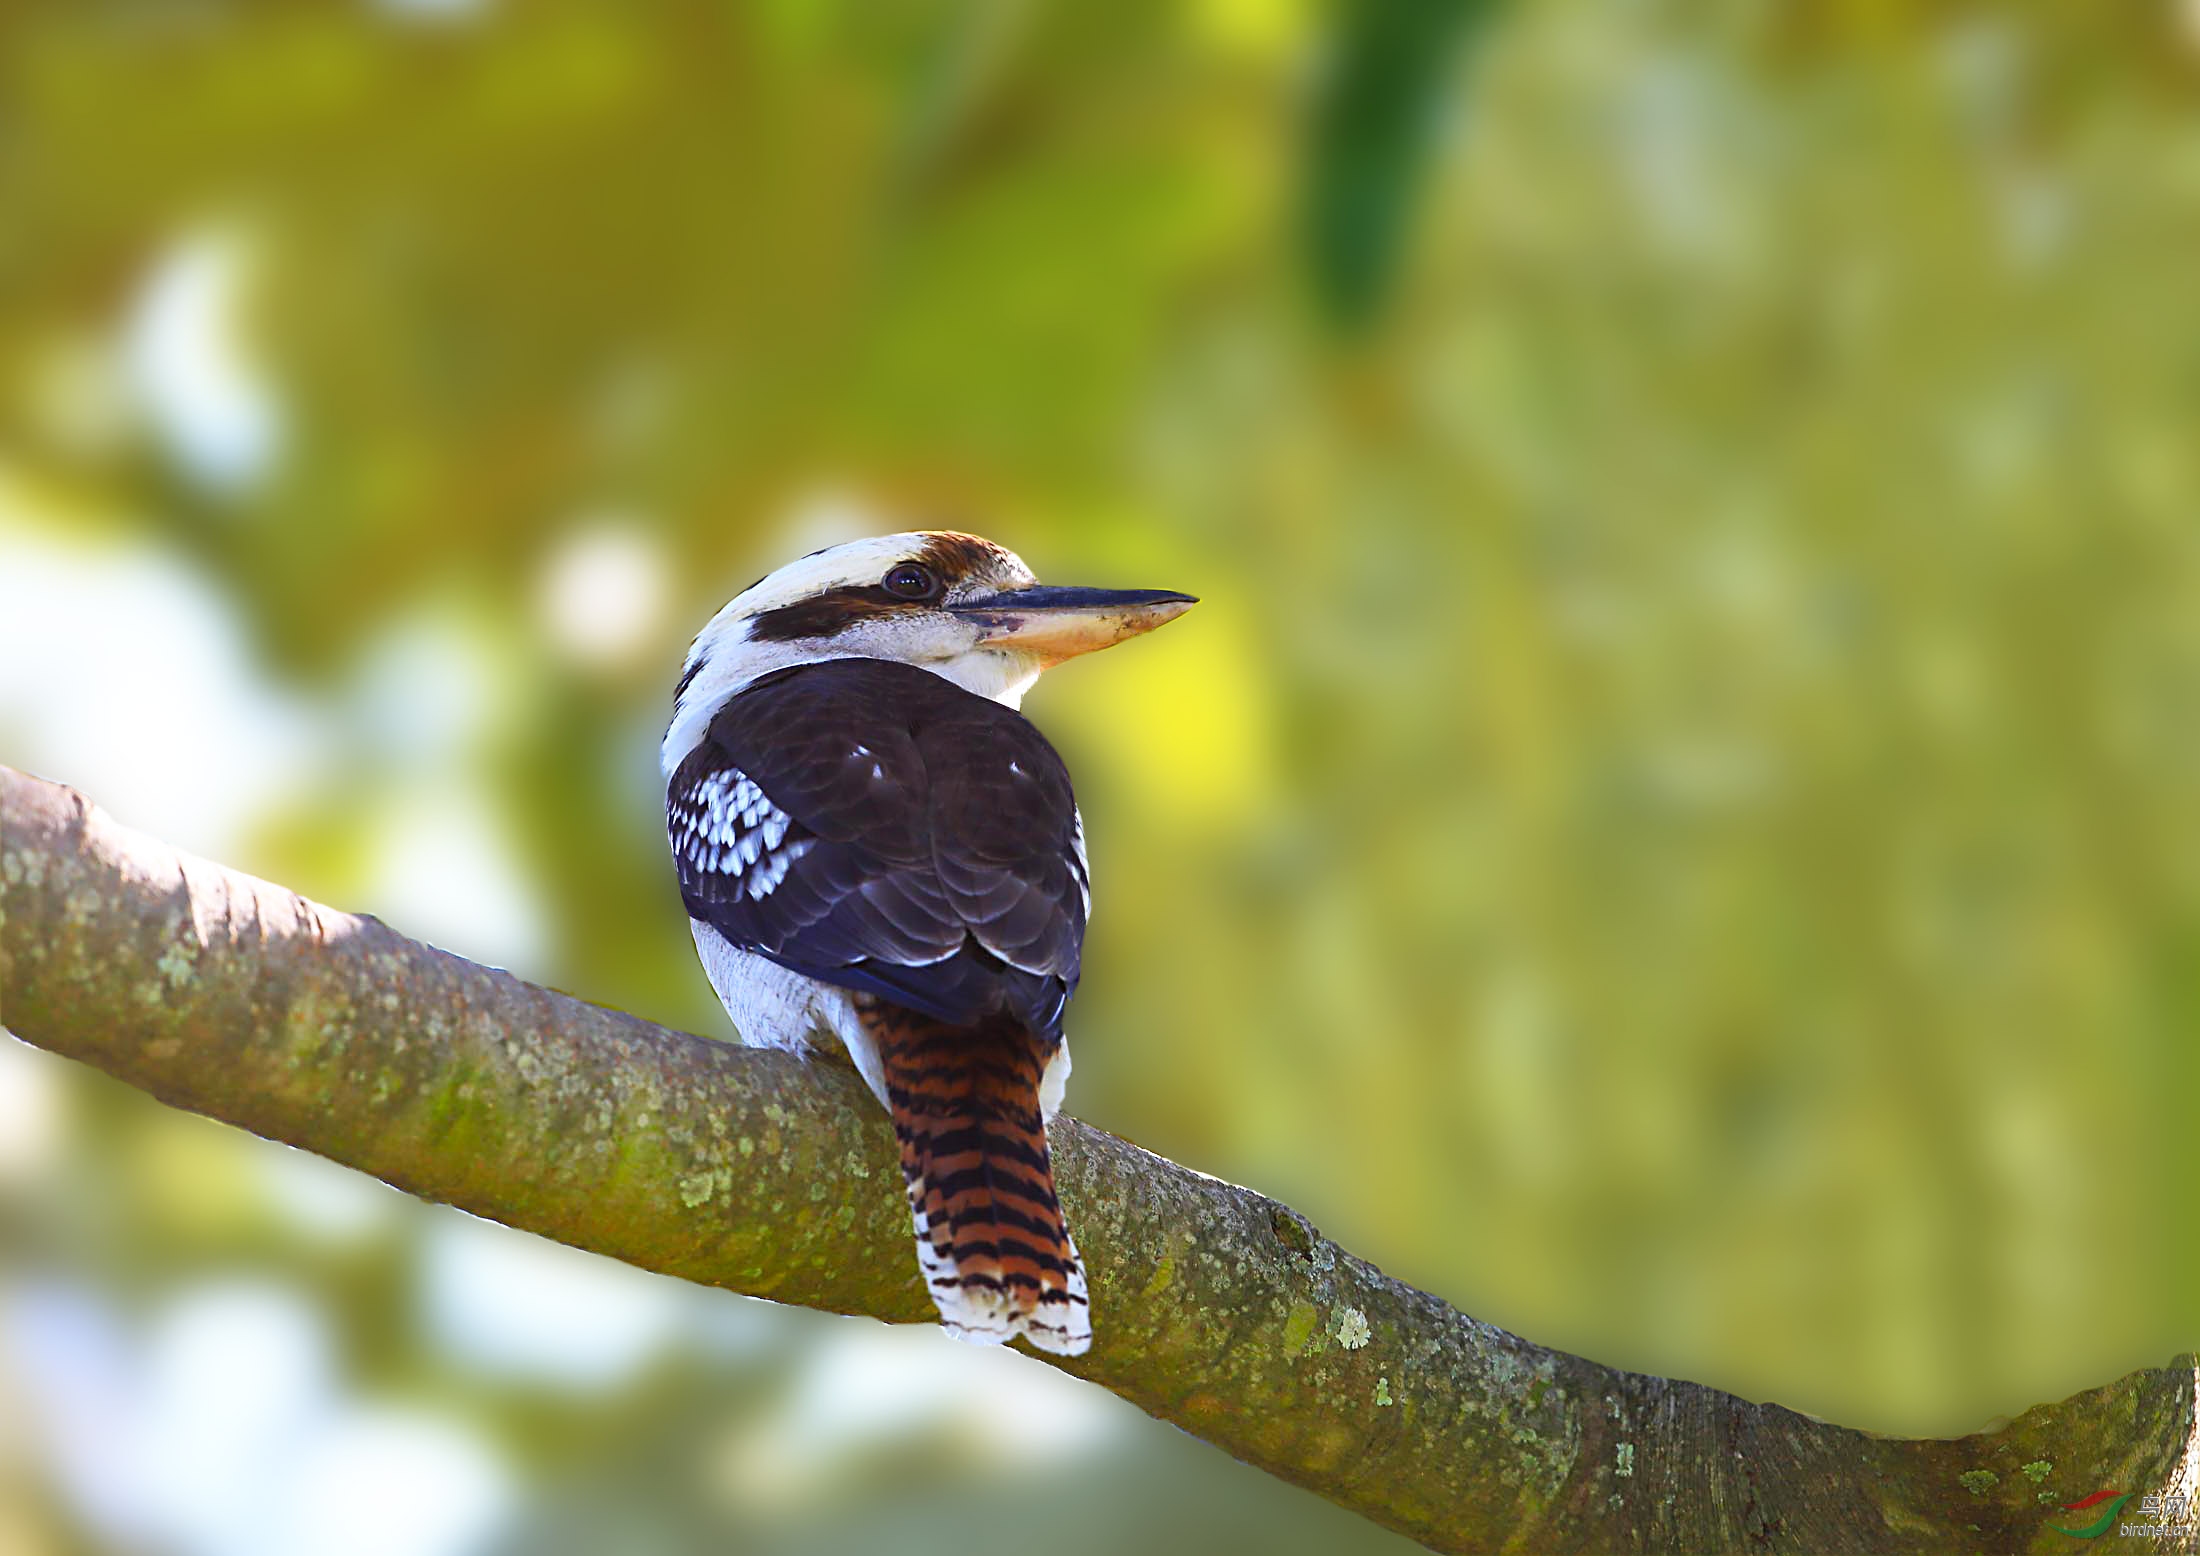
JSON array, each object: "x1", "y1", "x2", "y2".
[{"x1": 662, "y1": 533, "x2": 1195, "y2": 1356}]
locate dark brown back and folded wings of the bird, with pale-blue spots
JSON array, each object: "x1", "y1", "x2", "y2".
[{"x1": 667, "y1": 660, "x2": 1089, "y2": 1041}]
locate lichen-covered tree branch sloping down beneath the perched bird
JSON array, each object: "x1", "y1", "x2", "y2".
[{"x1": 0, "y1": 768, "x2": 2200, "y2": 1552}]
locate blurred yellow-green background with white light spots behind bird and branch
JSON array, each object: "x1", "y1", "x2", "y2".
[{"x1": 0, "y1": 0, "x2": 2200, "y2": 1556}]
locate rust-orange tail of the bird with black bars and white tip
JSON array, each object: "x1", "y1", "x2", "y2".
[{"x1": 858, "y1": 999, "x2": 1093, "y2": 1356}]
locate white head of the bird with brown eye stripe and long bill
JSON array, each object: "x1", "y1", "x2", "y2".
[{"x1": 662, "y1": 530, "x2": 1197, "y2": 775}]
